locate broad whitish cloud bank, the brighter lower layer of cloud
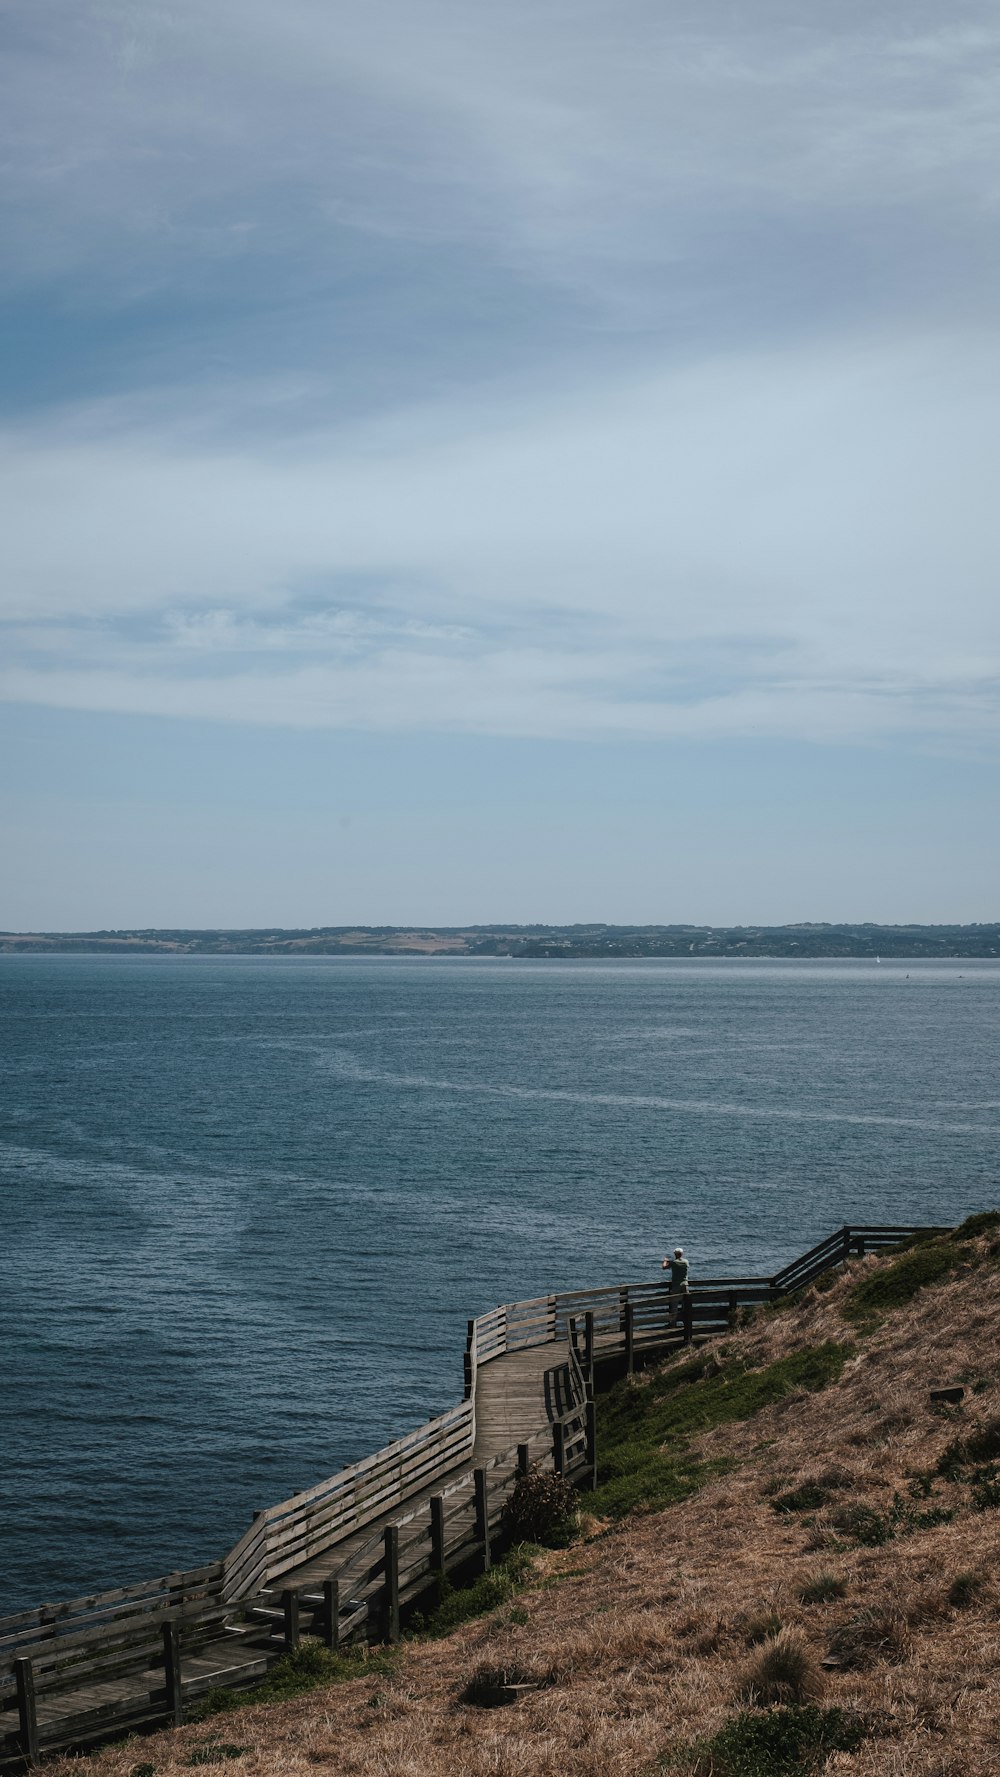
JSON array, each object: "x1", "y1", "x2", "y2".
[{"x1": 0, "y1": 338, "x2": 1000, "y2": 745}]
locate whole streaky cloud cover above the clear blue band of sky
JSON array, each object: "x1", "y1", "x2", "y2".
[{"x1": 0, "y1": 0, "x2": 1000, "y2": 746}]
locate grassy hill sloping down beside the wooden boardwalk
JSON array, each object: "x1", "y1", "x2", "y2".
[{"x1": 57, "y1": 1215, "x2": 1000, "y2": 1777}]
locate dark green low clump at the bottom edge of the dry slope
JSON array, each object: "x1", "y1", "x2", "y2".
[{"x1": 682, "y1": 1704, "x2": 865, "y2": 1777}]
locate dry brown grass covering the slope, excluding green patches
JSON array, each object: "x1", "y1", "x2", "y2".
[{"x1": 52, "y1": 1242, "x2": 1000, "y2": 1777}]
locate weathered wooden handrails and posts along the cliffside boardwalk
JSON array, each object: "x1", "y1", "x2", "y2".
[{"x1": 0, "y1": 1223, "x2": 947, "y2": 1761}]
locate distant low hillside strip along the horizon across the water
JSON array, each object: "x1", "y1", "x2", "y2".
[{"x1": 0, "y1": 922, "x2": 1000, "y2": 961}]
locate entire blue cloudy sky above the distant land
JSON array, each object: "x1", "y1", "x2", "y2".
[{"x1": 0, "y1": 0, "x2": 1000, "y2": 931}]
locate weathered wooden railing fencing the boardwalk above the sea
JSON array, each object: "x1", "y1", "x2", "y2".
[{"x1": 0, "y1": 1224, "x2": 945, "y2": 1766}]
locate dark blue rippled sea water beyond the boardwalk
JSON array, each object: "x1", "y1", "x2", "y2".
[{"x1": 0, "y1": 956, "x2": 1000, "y2": 1610}]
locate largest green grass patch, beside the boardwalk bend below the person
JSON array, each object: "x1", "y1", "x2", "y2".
[{"x1": 588, "y1": 1340, "x2": 853, "y2": 1518}]
